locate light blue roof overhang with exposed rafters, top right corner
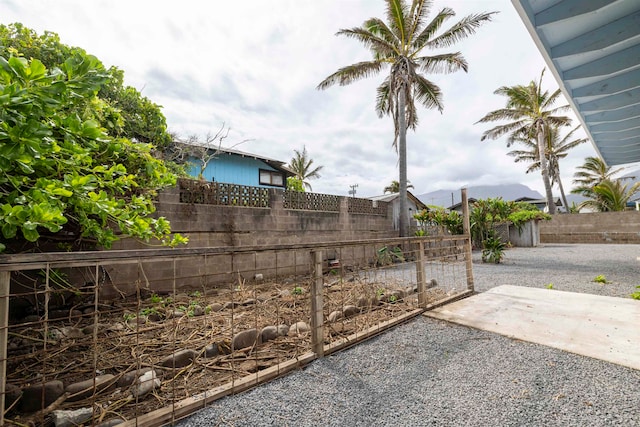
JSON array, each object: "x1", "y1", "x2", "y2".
[{"x1": 511, "y1": 0, "x2": 640, "y2": 166}]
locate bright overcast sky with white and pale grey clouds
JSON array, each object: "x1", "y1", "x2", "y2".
[{"x1": 0, "y1": 0, "x2": 608, "y2": 197}]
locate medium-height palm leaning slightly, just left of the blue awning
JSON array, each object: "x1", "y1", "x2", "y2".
[{"x1": 477, "y1": 70, "x2": 570, "y2": 214}]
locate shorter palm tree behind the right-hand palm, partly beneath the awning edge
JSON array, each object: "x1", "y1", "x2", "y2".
[{"x1": 507, "y1": 126, "x2": 587, "y2": 212}]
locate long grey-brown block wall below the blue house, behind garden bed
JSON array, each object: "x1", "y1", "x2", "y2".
[{"x1": 102, "y1": 188, "x2": 398, "y2": 297}]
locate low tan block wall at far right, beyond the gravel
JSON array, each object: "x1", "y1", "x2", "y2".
[{"x1": 540, "y1": 211, "x2": 640, "y2": 243}]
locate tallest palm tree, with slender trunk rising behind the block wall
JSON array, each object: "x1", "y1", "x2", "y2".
[{"x1": 318, "y1": 0, "x2": 493, "y2": 236}]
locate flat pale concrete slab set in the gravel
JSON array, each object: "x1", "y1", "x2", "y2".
[{"x1": 424, "y1": 285, "x2": 640, "y2": 370}]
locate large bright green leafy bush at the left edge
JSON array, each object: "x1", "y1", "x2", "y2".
[{"x1": 0, "y1": 27, "x2": 185, "y2": 252}]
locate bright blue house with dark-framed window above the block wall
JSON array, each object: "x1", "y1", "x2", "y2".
[{"x1": 187, "y1": 147, "x2": 294, "y2": 189}]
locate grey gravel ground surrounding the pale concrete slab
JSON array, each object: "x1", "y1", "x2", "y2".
[{"x1": 177, "y1": 245, "x2": 640, "y2": 427}]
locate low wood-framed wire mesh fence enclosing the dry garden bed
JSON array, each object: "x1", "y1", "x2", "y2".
[{"x1": 0, "y1": 235, "x2": 473, "y2": 426}]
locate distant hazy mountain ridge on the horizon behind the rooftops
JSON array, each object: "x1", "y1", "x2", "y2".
[{"x1": 416, "y1": 184, "x2": 544, "y2": 207}]
